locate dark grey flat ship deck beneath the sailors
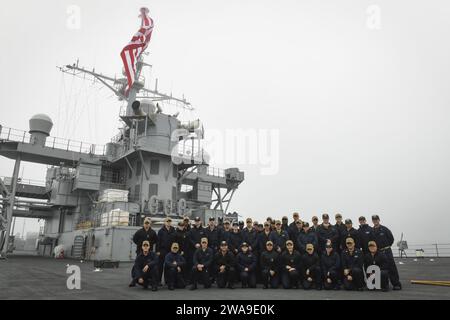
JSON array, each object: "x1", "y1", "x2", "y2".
[{"x1": 0, "y1": 255, "x2": 450, "y2": 300}]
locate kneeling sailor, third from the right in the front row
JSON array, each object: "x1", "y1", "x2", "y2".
[{"x1": 320, "y1": 243, "x2": 341, "y2": 290}]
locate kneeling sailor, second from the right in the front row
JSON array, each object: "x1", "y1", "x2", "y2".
[{"x1": 341, "y1": 238, "x2": 364, "y2": 291}]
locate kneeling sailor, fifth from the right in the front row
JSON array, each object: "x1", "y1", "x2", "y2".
[{"x1": 281, "y1": 240, "x2": 301, "y2": 289}]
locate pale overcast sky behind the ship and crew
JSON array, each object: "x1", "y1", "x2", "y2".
[{"x1": 0, "y1": 0, "x2": 450, "y2": 243}]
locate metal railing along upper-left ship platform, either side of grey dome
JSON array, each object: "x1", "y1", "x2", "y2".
[{"x1": 0, "y1": 126, "x2": 106, "y2": 155}]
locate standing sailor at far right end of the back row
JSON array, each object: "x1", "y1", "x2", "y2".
[{"x1": 372, "y1": 215, "x2": 402, "y2": 290}]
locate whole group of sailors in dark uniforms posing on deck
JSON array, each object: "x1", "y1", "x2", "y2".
[{"x1": 130, "y1": 212, "x2": 402, "y2": 291}]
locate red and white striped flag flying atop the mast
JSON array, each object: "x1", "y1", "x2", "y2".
[{"x1": 120, "y1": 8, "x2": 153, "y2": 96}]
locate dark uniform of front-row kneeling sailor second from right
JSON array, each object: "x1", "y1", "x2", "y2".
[{"x1": 341, "y1": 248, "x2": 364, "y2": 290}]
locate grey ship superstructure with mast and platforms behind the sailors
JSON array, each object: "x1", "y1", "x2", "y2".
[{"x1": 0, "y1": 58, "x2": 244, "y2": 261}]
